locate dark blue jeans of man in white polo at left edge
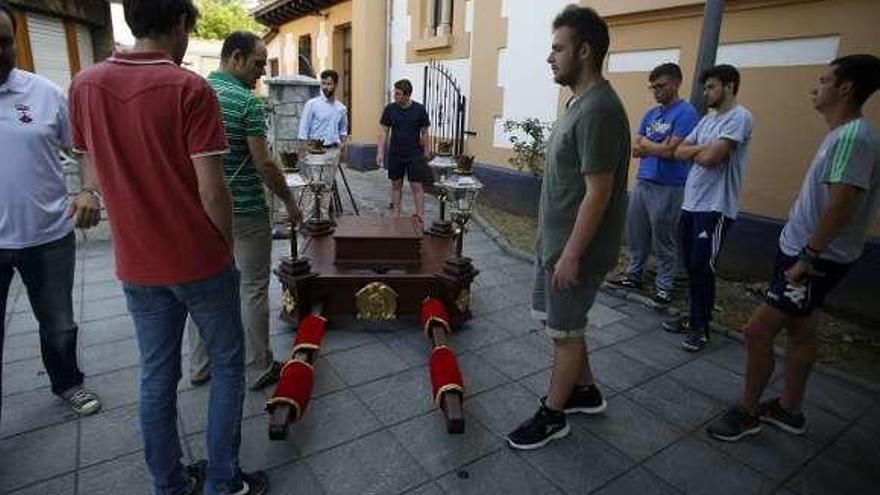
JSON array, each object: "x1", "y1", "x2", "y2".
[{"x1": 0, "y1": 232, "x2": 83, "y2": 418}]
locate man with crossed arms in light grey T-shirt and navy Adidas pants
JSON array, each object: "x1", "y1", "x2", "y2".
[{"x1": 663, "y1": 64, "x2": 752, "y2": 351}]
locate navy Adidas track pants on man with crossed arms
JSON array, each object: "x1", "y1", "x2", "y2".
[{"x1": 679, "y1": 211, "x2": 733, "y2": 330}]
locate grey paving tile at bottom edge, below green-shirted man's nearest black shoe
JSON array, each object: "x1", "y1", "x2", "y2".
[{"x1": 437, "y1": 449, "x2": 561, "y2": 495}]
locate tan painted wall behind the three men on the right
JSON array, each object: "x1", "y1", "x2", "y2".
[{"x1": 609, "y1": 0, "x2": 880, "y2": 233}]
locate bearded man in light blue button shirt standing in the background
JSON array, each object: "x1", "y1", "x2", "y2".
[{"x1": 297, "y1": 70, "x2": 348, "y2": 148}]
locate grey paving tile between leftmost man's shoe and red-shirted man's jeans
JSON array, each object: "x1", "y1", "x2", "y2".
[{"x1": 79, "y1": 404, "x2": 144, "y2": 466}]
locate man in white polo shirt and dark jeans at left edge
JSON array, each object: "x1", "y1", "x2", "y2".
[{"x1": 0, "y1": 0, "x2": 101, "y2": 422}]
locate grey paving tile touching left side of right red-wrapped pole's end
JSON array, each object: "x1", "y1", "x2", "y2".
[{"x1": 352, "y1": 366, "x2": 434, "y2": 425}]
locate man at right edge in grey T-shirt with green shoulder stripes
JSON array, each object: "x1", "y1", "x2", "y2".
[{"x1": 708, "y1": 55, "x2": 880, "y2": 442}]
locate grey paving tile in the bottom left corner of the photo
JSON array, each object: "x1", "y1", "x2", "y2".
[{"x1": 0, "y1": 421, "x2": 76, "y2": 490}]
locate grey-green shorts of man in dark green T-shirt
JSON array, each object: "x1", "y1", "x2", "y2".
[{"x1": 532, "y1": 263, "x2": 605, "y2": 339}]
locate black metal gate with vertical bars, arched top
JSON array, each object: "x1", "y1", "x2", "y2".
[{"x1": 422, "y1": 60, "x2": 467, "y2": 156}]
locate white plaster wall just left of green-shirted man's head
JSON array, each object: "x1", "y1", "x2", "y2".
[{"x1": 494, "y1": 0, "x2": 571, "y2": 148}]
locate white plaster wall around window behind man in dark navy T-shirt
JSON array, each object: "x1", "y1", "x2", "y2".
[{"x1": 385, "y1": 0, "x2": 476, "y2": 108}]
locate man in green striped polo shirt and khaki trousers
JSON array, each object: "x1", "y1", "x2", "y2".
[{"x1": 189, "y1": 32, "x2": 300, "y2": 390}]
